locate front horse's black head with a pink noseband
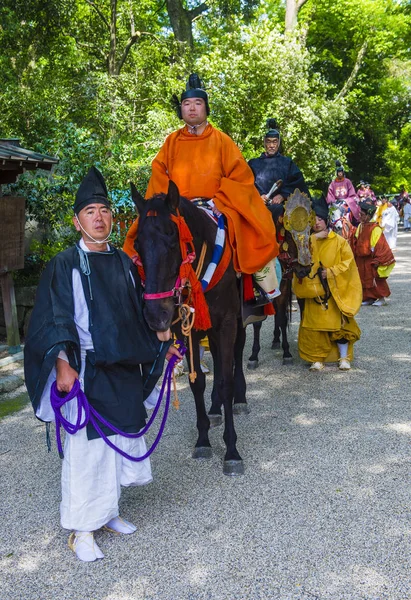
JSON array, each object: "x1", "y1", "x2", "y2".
[{"x1": 131, "y1": 181, "x2": 182, "y2": 331}]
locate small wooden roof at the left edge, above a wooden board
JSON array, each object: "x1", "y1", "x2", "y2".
[{"x1": 0, "y1": 138, "x2": 59, "y2": 185}]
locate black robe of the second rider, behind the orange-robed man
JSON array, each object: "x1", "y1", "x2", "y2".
[{"x1": 248, "y1": 152, "x2": 311, "y2": 199}]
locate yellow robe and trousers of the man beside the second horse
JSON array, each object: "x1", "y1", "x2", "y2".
[{"x1": 293, "y1": 232, "x2": 362, "y2": 362}]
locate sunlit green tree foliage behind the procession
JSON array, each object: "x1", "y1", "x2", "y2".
[{"x1": 0, "y1": 0, "x2": 411, "y2": 270}]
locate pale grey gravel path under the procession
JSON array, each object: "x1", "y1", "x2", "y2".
[{"x1": 0, "y1": 227, "x2": 411, "y2": 600}]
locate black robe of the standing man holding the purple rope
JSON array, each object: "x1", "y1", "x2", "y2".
[{"x1": 24, "y1": 246, "x2": 170, "y2": 439}]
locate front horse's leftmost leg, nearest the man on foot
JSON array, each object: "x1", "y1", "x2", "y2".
[{"x1": 187, "y1": 335, "x2": 213, "y2": 458}]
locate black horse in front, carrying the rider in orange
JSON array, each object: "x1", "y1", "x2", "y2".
[{"x1": 132, "y1": 181, "x2": 248, "y2": 475}]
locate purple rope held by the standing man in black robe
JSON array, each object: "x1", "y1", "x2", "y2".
[{"x1": 50, "y1": 343, "x2": 187, "y2": 462}]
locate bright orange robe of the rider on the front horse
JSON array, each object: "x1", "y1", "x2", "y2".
[{"x1": 128, "y1": 124, "x2": 278, "y2": 274}]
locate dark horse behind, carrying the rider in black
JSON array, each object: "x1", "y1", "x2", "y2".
[{"x1": 247, "y1": 205, "x2": 311, "y2": 369}]
